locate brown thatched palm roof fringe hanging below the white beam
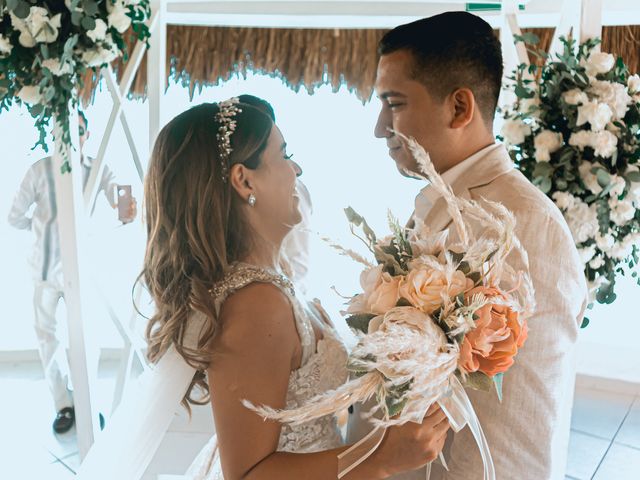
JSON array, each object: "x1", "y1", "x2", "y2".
[{"x1": 83, "y1": 25, "x2": 640, "y2": 102}]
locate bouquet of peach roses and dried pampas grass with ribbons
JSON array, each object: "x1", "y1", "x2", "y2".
[{"x1": 243, "y1": 134, "x2": 533, "y2": 478}]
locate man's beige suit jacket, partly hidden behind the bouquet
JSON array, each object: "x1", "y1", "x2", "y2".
[{"x1": 348, "y1": 144, "x2": 587, "y2": 480}]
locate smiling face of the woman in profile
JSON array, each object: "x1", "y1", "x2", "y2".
[{"x1": 252, "y1": 125, "x2": 302, "y2": 231}]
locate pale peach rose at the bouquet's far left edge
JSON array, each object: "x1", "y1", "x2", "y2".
[{"x1": 347, "y1": 265, "x2": 402, "y2": 314}]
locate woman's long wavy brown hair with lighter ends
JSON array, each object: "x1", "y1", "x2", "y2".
[{"x1": 141, "y1": 103, "x2": 273, "y2": 410}]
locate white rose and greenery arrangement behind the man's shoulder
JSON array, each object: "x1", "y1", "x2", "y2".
[{"x1": 501, "y1": 34, "x2": 640, "y2": 318}]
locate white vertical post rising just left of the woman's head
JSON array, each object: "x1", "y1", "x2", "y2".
[{"x1": 147, "y1": 0, "x2": 167, "y2": 152}]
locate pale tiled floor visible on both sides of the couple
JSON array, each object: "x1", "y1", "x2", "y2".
[{"x1": 0, "y1": 365, "x2": 640, "y2": 480}]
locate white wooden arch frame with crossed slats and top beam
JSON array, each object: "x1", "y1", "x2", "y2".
[{"x1": 56, "y1": 0, "x2": 640, "y2": 458}]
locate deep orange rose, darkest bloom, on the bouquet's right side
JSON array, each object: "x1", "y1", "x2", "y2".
[{"x1": 458, "y1": 287, "x2": 527, "y2": 377}]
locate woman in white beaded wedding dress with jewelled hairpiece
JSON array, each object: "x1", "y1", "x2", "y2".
[{"x1": 76, "y1": 96, "x2": 449, "y2": 480}]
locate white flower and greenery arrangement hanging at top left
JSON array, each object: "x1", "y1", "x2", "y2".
[{"x1": 0, "y1": 0, "x2": 151, "y2": 171}]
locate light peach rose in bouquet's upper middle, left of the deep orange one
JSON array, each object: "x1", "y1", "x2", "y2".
[{"x1": 400, "y1": 266, "x2": 473, "y2": 314}]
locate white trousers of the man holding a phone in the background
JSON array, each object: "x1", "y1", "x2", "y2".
[{"x1": 33, "y1": 282, "x2": 73, "y2": 412}]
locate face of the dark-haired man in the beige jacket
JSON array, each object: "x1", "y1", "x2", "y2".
[{"x1": 374, "y1": 50, "x2": 450, "y2": 176}]
